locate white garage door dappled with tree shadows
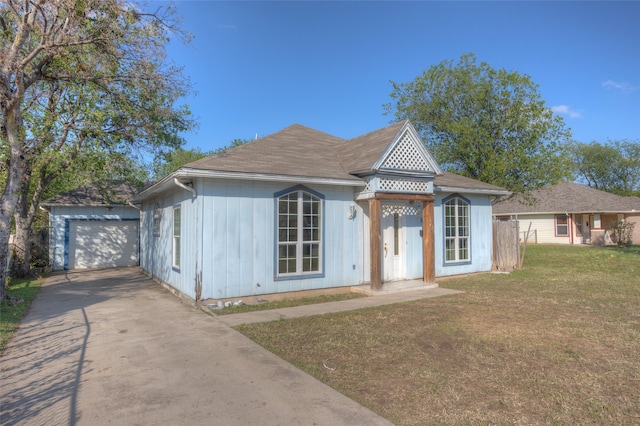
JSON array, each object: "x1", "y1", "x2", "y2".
[{"x1": 68, "y1": 220, "x2": 138, "y2": 269}]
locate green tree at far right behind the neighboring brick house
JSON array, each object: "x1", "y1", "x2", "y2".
[{"x1": 571, "y1": 139, "x2": 640, "y2": 196}]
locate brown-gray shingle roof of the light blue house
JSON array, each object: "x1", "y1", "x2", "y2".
[{"x1": 138, "y1": 121, "x2": 508, "y2": 199}]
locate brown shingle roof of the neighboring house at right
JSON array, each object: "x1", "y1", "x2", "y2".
[{"x1": 493, "y1": 182, "x2": 640, "y2": 215}]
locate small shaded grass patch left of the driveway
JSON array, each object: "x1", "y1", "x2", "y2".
[{"x1": 0, "y1": 279, "x2": 41, "y2": 355}]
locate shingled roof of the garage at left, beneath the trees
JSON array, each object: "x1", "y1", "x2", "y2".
[{"x1": 42, "y1": 181, "x2": 138, "y2": 207}]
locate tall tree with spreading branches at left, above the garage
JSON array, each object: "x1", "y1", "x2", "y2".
[{"x1": 0, "y1": 0, "x2": 194, "y2": 299}]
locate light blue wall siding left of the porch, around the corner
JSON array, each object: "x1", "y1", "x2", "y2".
[{"x1": 141, "y1": 179, "x2": 362, "y2": 299}]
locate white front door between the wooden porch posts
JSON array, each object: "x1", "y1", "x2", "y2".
[{"x1": 382, "y1": 213, "x2": 405, "y2": 281}]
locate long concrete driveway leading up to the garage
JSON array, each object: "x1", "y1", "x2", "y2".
[{"x1": 0, "y1": 268, "x2": 390, "y2": 425}]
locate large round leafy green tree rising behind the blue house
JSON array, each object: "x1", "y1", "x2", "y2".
[{"x1": 385, "y1": 54, "x2": 571, "y2": 193}]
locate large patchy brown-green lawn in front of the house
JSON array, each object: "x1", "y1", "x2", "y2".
[{"x1": 238, "y1": 245, "x2": 640, "y2": 425}]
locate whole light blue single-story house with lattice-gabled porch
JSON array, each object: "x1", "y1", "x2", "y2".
[{"x1": 136, "y1": 121, "x2": 508, "y2": 299}]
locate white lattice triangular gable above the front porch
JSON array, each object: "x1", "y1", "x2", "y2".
[{"x1": 373, "y1": 120, "x2": 442, "y2": 175}]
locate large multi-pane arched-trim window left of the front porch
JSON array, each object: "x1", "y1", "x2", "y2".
[{"x1": 276, "y1": 189, "x2": 322, "y2": 277}]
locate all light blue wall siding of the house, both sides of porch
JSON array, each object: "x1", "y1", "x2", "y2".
[{"x1": 140, "y1": 179, "x2": 492, "y2": 299}]
